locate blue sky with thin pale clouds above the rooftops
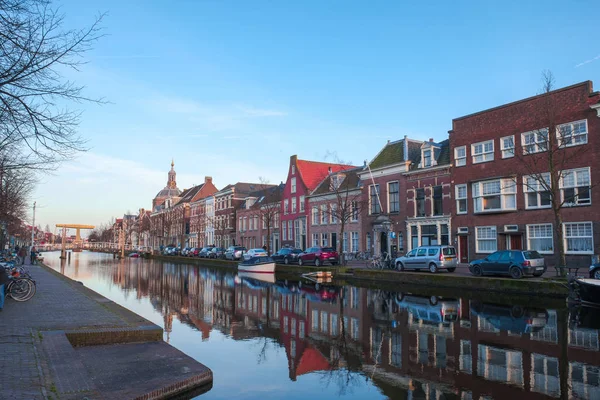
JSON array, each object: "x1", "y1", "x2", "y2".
[{"x1": 32, "y1": 0, "x2": 600, "y2": 234}]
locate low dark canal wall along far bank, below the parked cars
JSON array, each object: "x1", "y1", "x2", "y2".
[{"x1": 143, "y1": 255, "x2": 569, "y2": 299}]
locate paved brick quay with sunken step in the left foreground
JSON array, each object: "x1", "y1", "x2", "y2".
[{"x1": 0, "y1": 265, "x2": 213, "y2": 399}]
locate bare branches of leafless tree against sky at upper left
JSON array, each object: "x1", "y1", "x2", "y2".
[{"x1": 0, "y1": 0, "x2": 104, "y2": 170}]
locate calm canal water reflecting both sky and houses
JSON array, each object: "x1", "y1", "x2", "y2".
[{"x1": 44, "y1": 252, "x2": 600, "y2": 400}]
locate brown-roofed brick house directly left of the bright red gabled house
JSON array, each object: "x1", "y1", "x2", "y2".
[{"x1": 236, "y1": 184, "x2": 285, "y2": 253}]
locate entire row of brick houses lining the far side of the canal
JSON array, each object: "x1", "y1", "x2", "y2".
[{"x1": 117, "y1": 81, "x2": 600, "y2": 264}]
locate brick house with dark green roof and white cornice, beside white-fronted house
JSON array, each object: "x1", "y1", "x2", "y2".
[{"x1": 359, "y1": 136, "x2": 423, "y2": 255}]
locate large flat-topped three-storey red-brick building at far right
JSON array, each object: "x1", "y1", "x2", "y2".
[{"x1": 450, "y1": 81, "x2": 600, "y2": 265}]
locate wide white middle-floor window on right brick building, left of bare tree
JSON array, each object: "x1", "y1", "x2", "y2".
[{"x1": 472, "y1": 178, "x2": 517, "y2": 213}]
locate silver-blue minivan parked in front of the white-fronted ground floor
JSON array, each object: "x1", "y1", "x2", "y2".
[{"x1": 395, "y1": 245, "x2": 458, "y2": 273}]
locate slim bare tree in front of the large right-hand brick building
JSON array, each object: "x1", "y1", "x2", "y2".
[{"x1": 511, "y1": 71, "x2": 598, "y2": 276}]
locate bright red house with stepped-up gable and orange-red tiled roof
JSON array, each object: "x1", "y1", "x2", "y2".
[{"x1": 281, "y1": 155, "x2": 355, "y2": 249}]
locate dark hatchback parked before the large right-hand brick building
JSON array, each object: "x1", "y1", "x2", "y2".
[{"x1": 469, "y1": 250, "x2": 546, "y2": 279}]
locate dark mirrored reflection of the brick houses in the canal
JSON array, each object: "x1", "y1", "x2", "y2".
[{"x1": 99, "y1": 261, "x2": 600, "y2": 399}]
